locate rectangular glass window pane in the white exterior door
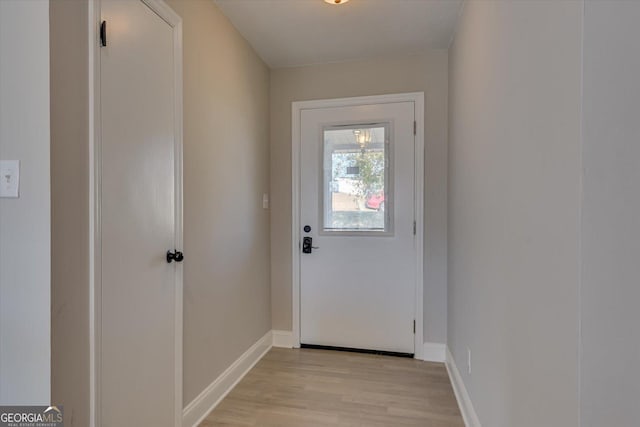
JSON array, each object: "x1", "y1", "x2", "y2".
[{"x1": 322, "y1": 124, "x2": 391, "y2": 232}]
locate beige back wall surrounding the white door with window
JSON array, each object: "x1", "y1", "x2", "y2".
[{"x1": 271, "y1": 51, "x2": 447, "y2": 343}]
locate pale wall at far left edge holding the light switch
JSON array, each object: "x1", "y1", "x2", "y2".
[{"x1": 0, "y1": 0, "x2": 51, "y2": 404}]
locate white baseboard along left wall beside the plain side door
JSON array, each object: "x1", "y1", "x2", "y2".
[{"x1": 182, "y1": 331, "x2": 273, "y2": 427}]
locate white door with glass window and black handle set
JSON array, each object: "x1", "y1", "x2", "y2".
[{"x1": 300, "y1": 102, "x2": 416, "y2": 354}]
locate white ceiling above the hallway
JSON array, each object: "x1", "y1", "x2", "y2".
[{"x1": 214, "y1": 0, "x2": 463, "y2": 68}]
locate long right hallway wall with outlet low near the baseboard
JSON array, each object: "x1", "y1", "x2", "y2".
[{"x1": 448, "y1": 1, "x2": 582, "y2": 427}]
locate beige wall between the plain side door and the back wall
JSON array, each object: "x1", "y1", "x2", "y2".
[{"x1": 164, "y1": 0, "x2": 271, "y2": 404}]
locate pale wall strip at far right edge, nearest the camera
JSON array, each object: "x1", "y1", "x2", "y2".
[{"x1": 581, "y1": 1, "x2": 640, "y2": 427}]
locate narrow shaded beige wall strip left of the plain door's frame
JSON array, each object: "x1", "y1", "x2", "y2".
[{"x1": 49, "y1": 0, "x2": 90, "y2": 427}]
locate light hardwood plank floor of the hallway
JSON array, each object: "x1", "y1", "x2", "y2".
[{"x1": 200, "y1": 348, "x2": 464, "y2": 427}]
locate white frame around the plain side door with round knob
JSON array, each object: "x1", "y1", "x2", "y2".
[{"x1": 87, "y1": 0, "x2": 183, "y2": 427}]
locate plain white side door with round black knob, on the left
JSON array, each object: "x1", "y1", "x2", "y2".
[{"x1": 99, "y1": 0, "x2": 182, "y2": 427}]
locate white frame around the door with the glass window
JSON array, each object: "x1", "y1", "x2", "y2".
[{"x1": 291, "y1": 92, "x2": 424, "y2": 360}]
